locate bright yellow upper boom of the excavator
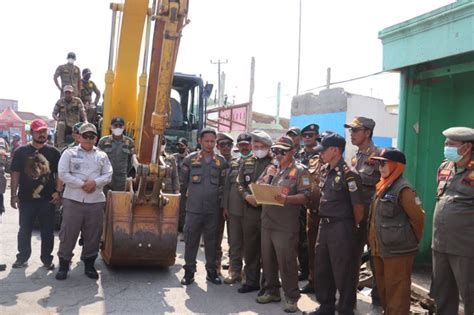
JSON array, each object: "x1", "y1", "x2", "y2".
[{"x1": 103, "y1": 0, "x2": 148, "y2": 142}]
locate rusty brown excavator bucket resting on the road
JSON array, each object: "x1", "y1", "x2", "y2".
[{"x1": 101, "y1": 180, "x2": 180, "y2": 267}]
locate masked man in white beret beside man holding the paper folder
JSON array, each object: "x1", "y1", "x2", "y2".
[{"x1": 237, "y1": 130, "x2": 273, "y2": 293}]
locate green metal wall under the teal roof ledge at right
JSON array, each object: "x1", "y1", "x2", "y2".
[{"x1": 399, "y1": 54, "x2": 474, "y2": 263}]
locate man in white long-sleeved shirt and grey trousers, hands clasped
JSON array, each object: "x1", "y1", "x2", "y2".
[{"x1": 56, "y1": 123, "x2": 112, "y2": 280}]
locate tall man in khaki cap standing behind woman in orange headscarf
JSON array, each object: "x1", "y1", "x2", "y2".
[{"x1": 344, "y1": 116, "x2": 382, "y2": 312}]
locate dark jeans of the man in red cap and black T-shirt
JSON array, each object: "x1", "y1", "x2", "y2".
[{"x1": 16, "y1": 200, "x2": 54, "y2": 264}]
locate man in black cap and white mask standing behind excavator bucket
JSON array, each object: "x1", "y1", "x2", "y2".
[{"x1": 97, "y1": 117, "x2": 135, "y2": 191}]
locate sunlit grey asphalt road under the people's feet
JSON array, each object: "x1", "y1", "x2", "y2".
[{"x1": 0, "y1": 191, "x2": 369, "y2": 315}]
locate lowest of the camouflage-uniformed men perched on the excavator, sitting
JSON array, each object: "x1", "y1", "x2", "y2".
[{"x1": 53, "y1": 85, "x2": 87, "y2": 149}]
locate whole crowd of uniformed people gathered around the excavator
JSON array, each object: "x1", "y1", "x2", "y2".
[{"x1": 0, "y1": 50, "x2": 474, "y2": 315}]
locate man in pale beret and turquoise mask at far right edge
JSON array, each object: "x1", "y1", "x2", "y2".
[{"x1": 431, "y1": 127, "x2": 474, "y2": 315}]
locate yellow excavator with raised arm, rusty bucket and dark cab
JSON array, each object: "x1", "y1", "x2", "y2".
[{"x1": 101, "y1": 0, "x2": 212, "y2": 266}]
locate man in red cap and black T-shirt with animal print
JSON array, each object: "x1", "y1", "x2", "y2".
[{"x1": 11, "y1": 119, "x2": 62, "y2": 270}]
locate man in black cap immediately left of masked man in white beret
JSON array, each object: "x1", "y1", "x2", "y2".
[{"x1": 223, "y1": 133, "x2": 253, "y2": 284}]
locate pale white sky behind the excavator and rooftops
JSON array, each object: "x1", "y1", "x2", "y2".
[{"x1": 0, "y1": 0, "x2": 454, "y2": 117}]
